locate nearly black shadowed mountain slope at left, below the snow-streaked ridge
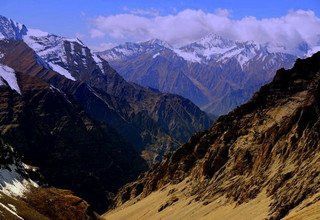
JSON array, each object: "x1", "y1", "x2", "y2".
[{"x1": 0, "y1": 60, "x2": 146, "y2": 212}]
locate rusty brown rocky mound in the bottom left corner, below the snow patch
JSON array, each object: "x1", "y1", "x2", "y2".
[{"x1": 0, "y1": 188, "x2": 100, "y2": 220}]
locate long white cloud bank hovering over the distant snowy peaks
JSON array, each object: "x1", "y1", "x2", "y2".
[{"x1": 91, "y1": 9, "x2": 320, "y2": 55}]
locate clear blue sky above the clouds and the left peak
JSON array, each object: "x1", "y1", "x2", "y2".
[{"x1": 0, "y1": 0, "x2": 320, "y2": 47}]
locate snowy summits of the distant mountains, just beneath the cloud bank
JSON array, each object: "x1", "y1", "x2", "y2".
[{"x1": 98, "y1": 33, "x2": 316, "y2": 70}]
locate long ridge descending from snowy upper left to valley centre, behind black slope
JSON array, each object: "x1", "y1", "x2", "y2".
[{"x1": 0, "y1": 14, "x2": 211, "y2": 164}]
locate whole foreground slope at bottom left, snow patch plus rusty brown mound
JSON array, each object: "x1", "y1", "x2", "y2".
[{"x1": 0, "y1": 139, "x2": 98, "y2": 219}]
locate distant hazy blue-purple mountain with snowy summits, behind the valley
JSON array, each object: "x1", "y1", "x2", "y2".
[{"x1": 97, "y1": 34, "x2": 296, "y2": 115}]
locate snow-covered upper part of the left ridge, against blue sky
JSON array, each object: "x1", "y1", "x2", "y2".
[{"x1": 0, "y1": 16, "x2": 95, "y2": 80}]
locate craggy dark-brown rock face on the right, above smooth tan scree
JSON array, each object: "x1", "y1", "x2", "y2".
[{"x1": 114, "y1": 53, "x2": 320, "y2": 219}]
